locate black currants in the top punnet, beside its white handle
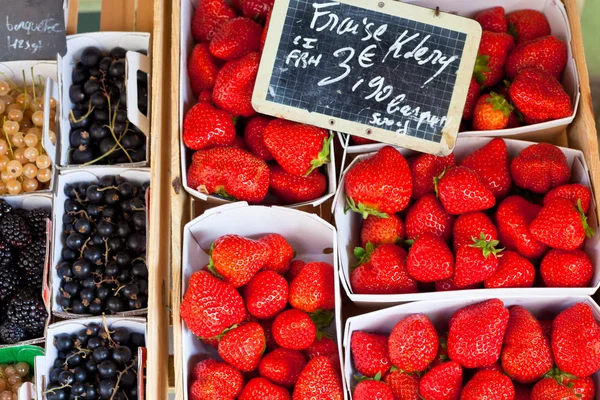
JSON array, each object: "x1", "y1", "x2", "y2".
[{"x1": 69, "y1": 47, "x2": 148, "y2": 165}]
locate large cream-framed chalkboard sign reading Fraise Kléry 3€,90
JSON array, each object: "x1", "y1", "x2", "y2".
[{"x1": 252, "y1": 0, "x2": 481, "y2": 154}]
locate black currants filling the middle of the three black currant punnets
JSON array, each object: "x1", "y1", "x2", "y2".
[{"x1": 56, "y1": 175, "x2": 149, "y2": 315}]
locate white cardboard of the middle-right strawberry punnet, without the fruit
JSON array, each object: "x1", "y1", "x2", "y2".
[{"x1": 333, "y1": 137, "x2": 600, "y2": 306}]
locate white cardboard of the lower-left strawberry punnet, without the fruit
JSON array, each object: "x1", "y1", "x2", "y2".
[{"x1": 181, "y1": 202, "x2": 342, "y2": 400}]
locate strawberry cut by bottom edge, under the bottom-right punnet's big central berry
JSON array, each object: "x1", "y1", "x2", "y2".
[{"x1": 460, "y1": 371, "x2": 515, "y2": 400}]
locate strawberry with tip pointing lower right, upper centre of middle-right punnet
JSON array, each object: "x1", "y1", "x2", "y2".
[{"x1": 437, "y1": 167, "x2": 496, "y2": 214}]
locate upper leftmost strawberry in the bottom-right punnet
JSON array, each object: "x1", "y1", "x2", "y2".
[{"x1": 350, "y1": 331, "x2": 392, "y2": 378}]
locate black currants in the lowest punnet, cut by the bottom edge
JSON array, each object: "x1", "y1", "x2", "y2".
[{"x1": 45, "y1": 323, "x2": 145, "y2": 400}]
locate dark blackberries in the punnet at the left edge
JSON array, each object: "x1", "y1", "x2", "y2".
[{"x1": 0, "y1": 199, "x2": 51, "y2": 344}]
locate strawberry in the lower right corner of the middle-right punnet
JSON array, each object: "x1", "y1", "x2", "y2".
[{"x1": 540, "y1": 249, "x2": 594, "y2": 287}]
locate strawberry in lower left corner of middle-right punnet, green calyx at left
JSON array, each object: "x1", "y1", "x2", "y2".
[{"x1": 350, "y1": 244, "x2": 417, "y2": 294}]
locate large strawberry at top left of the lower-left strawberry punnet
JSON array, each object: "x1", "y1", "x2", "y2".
[{"x1": 208, "y1": 235, "x2": 269, "y2": 287}]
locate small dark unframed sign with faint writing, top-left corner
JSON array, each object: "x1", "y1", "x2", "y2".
[{"x1": 0, "y1": 0, "x2": 67, "y2": 61}]
